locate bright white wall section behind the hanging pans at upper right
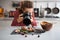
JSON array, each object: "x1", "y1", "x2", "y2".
[{"x1": 34, "y1": 2, "x2": 60, "y2": 17}]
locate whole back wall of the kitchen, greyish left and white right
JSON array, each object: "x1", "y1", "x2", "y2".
[{"x1": 0, "y1": 0, "x2": 60, "y2": 16}]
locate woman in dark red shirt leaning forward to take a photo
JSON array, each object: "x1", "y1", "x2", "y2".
[{"x1": 11, "y1": 1, "x2": 37, "y2": 26}]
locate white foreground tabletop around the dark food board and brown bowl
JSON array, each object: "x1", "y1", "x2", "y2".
[{"x1": 0, "y1": 21, "x2": 60, "y2": 40}]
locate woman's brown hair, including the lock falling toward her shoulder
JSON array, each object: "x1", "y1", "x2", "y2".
[{"x1": 19, "y1": 1, "x2": 33, "y2": 14}]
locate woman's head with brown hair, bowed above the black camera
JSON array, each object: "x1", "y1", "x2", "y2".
[{"x1": 21, "y1": 1, "x2": 33, "y2": 12}]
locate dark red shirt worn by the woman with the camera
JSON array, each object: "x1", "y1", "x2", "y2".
[{"x1": 11, "y1": 11, "x2": 37, "y2": 26}]
